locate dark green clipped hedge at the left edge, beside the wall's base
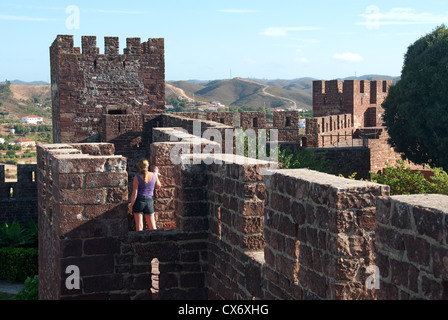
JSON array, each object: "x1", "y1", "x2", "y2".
[{"x1": 0, "y1": 248, "x2": 38, "y2": 281}]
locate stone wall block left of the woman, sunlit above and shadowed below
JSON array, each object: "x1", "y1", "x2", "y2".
[{"x1": 37, "y1": 144, "x2": 128, "y2": 300}]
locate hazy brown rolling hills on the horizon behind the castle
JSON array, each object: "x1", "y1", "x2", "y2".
[{"x1": 0, "y1": 74, "x2": 400, "y2": 121}]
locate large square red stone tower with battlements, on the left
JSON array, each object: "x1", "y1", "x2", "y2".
[{"x1": 50, "y1": 35, "x2": 165, "y2": 143}]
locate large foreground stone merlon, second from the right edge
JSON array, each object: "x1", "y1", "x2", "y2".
[{"x1": 264, "y1": 170, "x2": 389, "y2": 300}]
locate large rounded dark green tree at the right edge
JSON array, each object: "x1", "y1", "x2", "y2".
[{"x1": 383, "y1": 25, "x2": 448, "y2": 170}]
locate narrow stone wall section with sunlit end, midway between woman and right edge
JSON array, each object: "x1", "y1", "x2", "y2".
[{"x1": 207, "y1": 157, "x2": 269, "y2": 300}]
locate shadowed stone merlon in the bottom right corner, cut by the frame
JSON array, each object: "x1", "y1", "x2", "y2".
[{"x1": 376, "y1": 195, "x2": 448, "y2": 300}]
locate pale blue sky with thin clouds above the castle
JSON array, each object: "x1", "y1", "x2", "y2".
[{"x1": 0, "y1": 0, "x2": 448, "y2": 82}]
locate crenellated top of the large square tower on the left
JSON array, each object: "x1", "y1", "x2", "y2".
[{"x1": 51, "y1": 35, "x2": 165, "y2": 55}]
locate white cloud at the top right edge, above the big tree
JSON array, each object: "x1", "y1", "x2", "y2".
[{"x1": 356, "y1": 6, "x2": 448, "y2": 29}]
